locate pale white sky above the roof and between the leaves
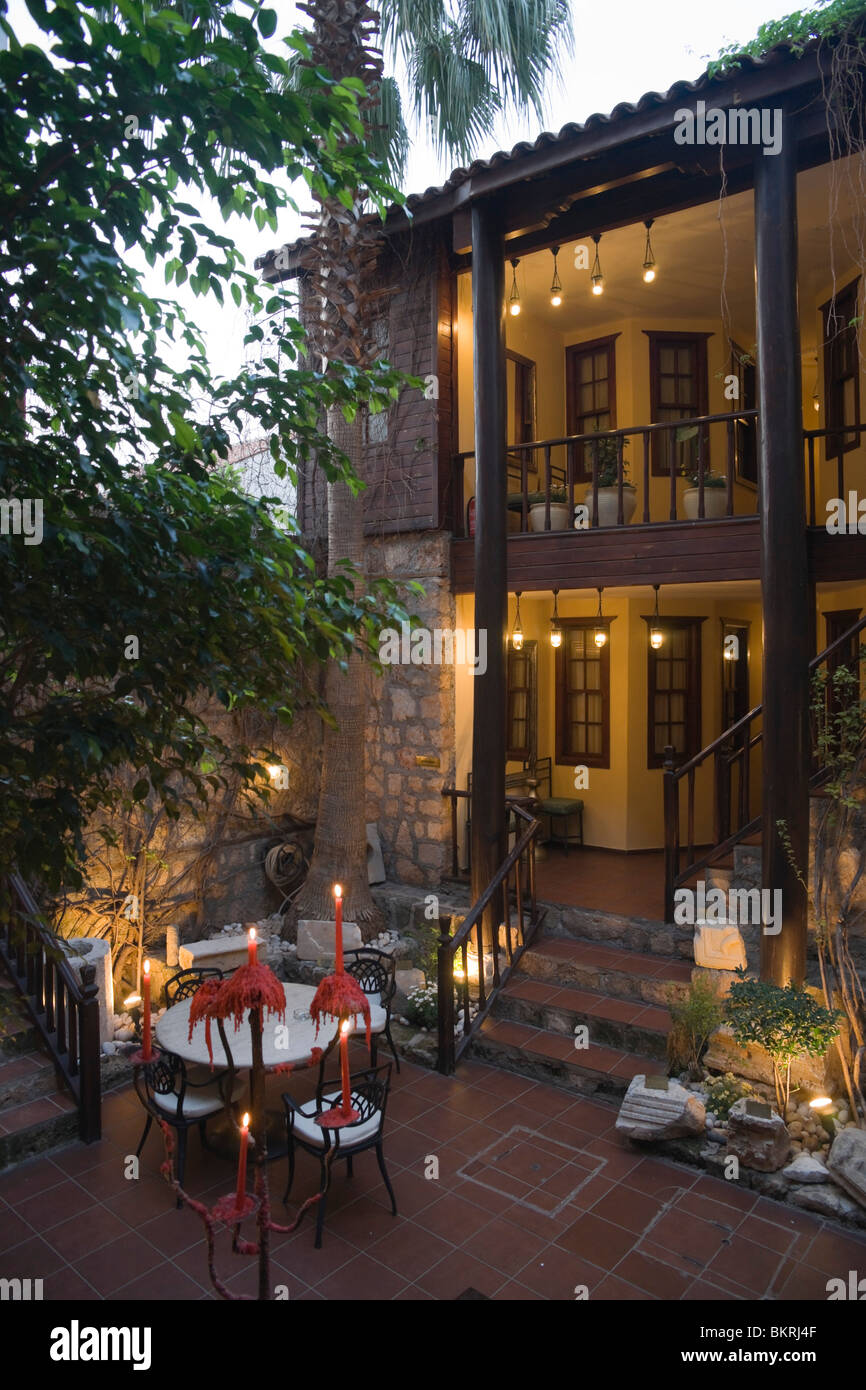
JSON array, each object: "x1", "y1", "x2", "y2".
[{"x1": 8, "y1": 0, "x2": 791, "y2": 391}]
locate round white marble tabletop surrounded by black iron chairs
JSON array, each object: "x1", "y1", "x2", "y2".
[{"x1": 156, "y1": 984, "x2": 323, "y2": 1072}]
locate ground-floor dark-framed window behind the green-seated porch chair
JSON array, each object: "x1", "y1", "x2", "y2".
[{"x1": 555, "y1": 617, "x2": 610, "y2": 767}]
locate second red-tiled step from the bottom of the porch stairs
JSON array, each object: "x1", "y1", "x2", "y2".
[{"x1": 492, "y1": 974, "x2": 670, "y2": 1059}]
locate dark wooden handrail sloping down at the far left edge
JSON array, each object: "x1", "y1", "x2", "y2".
[{"x1": 0, "y1": 873, "x2": 101, "y2": 1144}]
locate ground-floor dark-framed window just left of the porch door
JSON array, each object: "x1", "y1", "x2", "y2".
[{"x1": 644, "y1": 616, "x2": 703, "y2": 767}]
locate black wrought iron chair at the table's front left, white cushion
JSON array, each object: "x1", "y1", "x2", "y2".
[{"x1": 133, "y1": 1019, "x2": 245, "y2": 1207}]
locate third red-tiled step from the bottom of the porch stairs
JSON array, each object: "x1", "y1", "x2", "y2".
[{"x1": 520, "y1": 937, "x2": 694, "y2": 1008}]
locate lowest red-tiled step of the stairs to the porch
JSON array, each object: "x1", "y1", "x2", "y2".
[{"x1": 468, "y1": 1017, "x2": 664, "y2": 1097}]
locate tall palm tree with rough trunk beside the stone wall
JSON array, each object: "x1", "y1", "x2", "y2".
[{"x1": 293, "y1": 0, "x2": 571, "y2": 935}]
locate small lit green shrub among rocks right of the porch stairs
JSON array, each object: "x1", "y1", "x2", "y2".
[{"x1": 726, "y1": 976, "x2": 844, "y2": 1116}]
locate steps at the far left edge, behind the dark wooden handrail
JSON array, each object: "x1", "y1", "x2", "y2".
[{"x1": 0, "y1": 967, "x2": 78, "y2": 1170}]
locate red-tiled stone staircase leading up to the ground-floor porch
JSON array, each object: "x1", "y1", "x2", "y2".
[{"x1": 470, "y1": 908, "x2": 692, "y2": 1097}]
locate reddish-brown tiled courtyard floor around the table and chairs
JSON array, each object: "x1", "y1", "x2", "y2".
[{"x1": 0, "y1": 1048, "x2": 866, "y2": 1301}]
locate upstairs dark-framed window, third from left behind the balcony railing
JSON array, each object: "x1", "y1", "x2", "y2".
[{"x1": 644, "y1": 329, "x2": 712, "y2": 477}]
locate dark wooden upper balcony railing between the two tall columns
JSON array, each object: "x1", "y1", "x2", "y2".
[{"x1": 450, "y1": 410, "x2": 758, "y2": 537}]
